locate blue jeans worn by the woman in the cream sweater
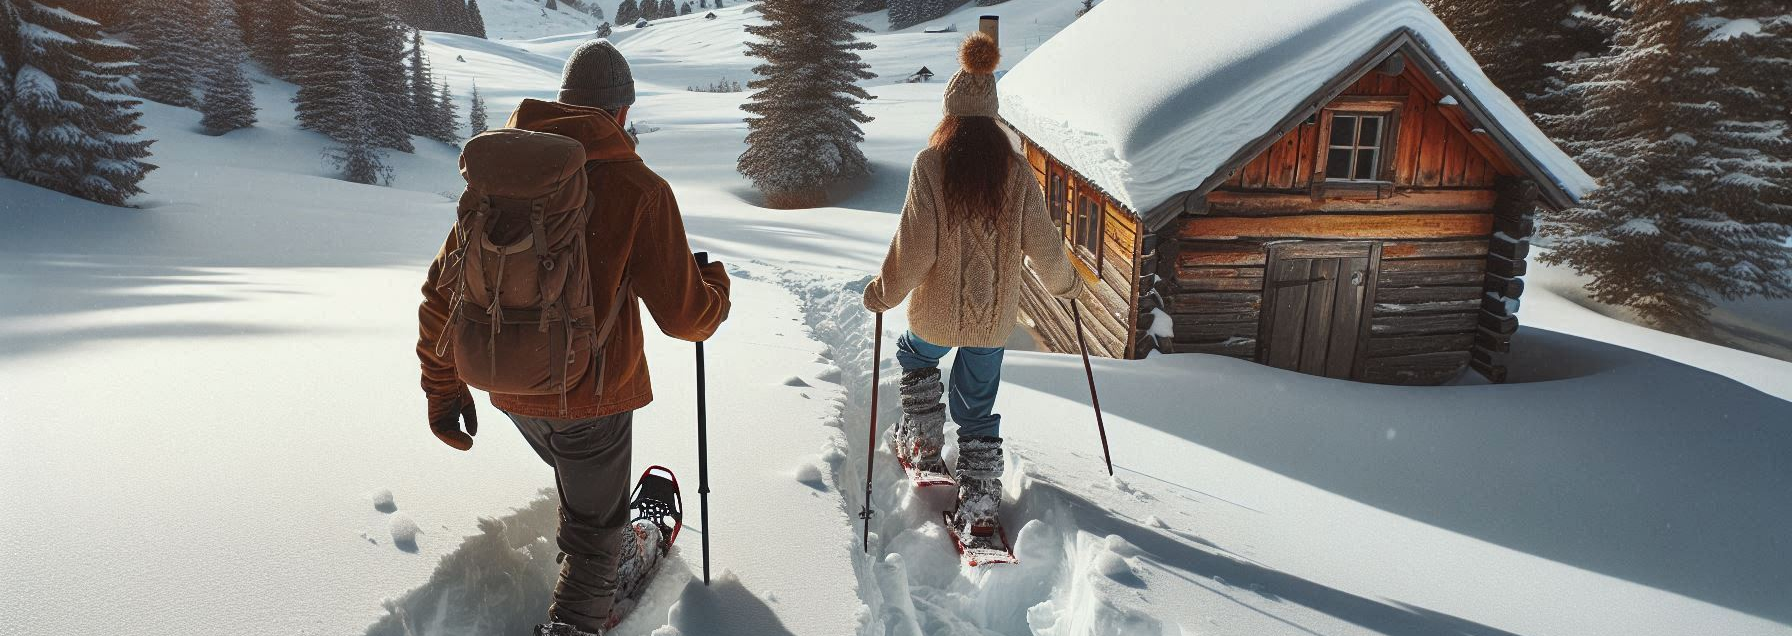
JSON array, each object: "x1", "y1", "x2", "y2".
[{"x1": 896, "y1": 331, "x2": 1005, "y2": 437}]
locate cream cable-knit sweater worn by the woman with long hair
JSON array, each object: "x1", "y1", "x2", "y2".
[{"x1": 866, "y1": 149, "x2": 1079, "y2": 348}]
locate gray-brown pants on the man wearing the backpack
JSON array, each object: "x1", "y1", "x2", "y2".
[{"x1": 507, "y1": 410, "x2": 634, "y2": 634}]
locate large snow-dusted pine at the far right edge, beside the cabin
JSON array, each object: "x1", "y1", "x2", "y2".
[{"x1": 1541, "y1": 0, "x2": 1792, "y2": 337}]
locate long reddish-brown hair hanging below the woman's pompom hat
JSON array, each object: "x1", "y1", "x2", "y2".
[{"x1": 928, "y1": 115, "x2": 1014, "y2": 231}]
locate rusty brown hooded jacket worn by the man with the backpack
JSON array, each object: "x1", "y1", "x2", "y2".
[{"x1": 418, "y1": 100, "x2": 729, "y2": 419}]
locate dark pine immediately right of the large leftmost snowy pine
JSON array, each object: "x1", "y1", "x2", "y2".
[{"x1": 136, "y1": 0, "x2": 206, "y2": 106}]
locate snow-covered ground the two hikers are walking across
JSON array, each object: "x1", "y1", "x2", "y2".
[{"x1": 0, "y1": 0, "x2": 1792, "y2": 636}]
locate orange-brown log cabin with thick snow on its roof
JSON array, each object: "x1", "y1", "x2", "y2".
[{"x1": 1000, "y1": 0, "x2": 1593, "y2": 385}]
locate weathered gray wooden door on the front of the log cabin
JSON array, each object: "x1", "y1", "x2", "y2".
[{"x1": 1262, "y1": 242, "x2": 1382, "y2": 378}]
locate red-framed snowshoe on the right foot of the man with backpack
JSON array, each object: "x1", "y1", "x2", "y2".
[{"x1": 605, "y1": 466, "x2": 685, "y2": 636}]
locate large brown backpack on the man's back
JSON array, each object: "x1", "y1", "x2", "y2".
[{"x1": 435, "y1": 129, "x2": 629, "y2": 414}]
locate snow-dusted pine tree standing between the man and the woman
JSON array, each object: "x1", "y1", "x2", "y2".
[{"x1": 738, "y1": 0, "x2": 876, "y2": 208}]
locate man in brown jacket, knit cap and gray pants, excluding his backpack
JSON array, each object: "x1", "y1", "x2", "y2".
[{"x1": 418, "y1": 39, "x2": 729, "y2": 636}]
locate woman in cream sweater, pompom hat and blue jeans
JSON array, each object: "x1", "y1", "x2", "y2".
[{"x1": 866, "y1": 34, "x2": 1077, "y2": 537}]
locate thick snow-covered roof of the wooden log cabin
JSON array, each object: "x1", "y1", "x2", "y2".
[{"x1": 1000, "y1": 0, "x2": 1593, "y2": 229}]
